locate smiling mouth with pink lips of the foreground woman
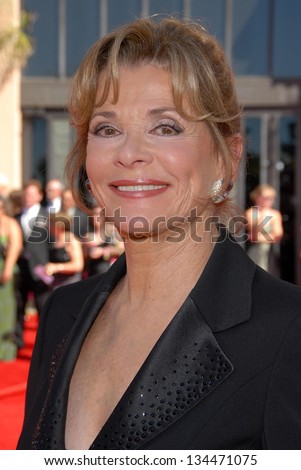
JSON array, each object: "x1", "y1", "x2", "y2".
[{"x1": 109, "y1": 178, "x2": 170, "y2": 199}]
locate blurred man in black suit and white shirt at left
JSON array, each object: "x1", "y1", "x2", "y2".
[{"x1": 15, "y1": 179, "x2": 50, "y2": 348}]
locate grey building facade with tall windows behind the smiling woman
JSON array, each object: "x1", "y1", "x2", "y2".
[{"x1": 21, "y1": 0, "x2": 301, "y2": 285}]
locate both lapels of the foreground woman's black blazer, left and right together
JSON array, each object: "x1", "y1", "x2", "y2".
[{"x1": 31, "y1": 229, "x2": 255, "y2": 450}]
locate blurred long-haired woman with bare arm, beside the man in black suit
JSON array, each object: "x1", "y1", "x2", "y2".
[{"x1": 43, "y1": 212, "x2": 84, "y2": 289}]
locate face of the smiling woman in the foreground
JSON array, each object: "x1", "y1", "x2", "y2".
[{"x1": 86, "y1": 65, "x2": 222, "y2": 237}]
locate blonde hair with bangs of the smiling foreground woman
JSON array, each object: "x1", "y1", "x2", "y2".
[{"x1": 65, "y1": 18, "x2": 241, "y2": 208}]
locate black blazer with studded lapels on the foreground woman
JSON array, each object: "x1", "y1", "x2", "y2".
[{"x1": 18, "y1": 233, "x2": 301, "y2": 449}]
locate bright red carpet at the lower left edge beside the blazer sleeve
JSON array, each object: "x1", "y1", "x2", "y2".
[{"x1": 0, "y1": 315, "x2": 38, "y2": 450}]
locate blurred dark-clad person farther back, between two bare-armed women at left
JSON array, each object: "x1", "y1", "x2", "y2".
[{"x1": 62, "y1": 188, "x2": 90, "y2": 239}]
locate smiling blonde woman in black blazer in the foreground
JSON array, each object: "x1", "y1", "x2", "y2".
[{"x1": 18, "y1": 19, "x2": 301, "y2": 449}]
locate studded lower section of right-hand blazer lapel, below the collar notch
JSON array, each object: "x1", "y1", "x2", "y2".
[{"x1": 91, "y1": 297, "x2": 233, "y2": 450}]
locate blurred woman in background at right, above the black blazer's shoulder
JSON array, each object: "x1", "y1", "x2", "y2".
[{"x1": 246, "y1": 184, "x2": 283, "y2": 275}]
